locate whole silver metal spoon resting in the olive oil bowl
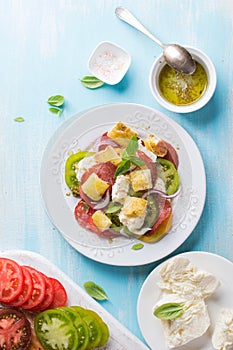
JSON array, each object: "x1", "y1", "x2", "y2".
[{"x1": 115, "y1": 7, "x2": 196, "y2": 74}]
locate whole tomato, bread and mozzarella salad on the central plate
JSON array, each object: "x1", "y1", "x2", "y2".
[{"x1": 65, "y1": 122, "x2": 179, "y2": 242}]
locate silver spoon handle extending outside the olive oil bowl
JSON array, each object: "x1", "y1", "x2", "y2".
[{"x1": 115, "y1": 7, "x2": 164, "y2": 47}]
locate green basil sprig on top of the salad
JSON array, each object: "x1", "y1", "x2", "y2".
[{"x1": 114, "y1": 136, "x2": 145, "y2": 178}]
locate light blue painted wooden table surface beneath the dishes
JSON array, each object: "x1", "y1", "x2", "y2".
[{"x1": 0, "y1": 0, "x2": 233, "y2": 348}]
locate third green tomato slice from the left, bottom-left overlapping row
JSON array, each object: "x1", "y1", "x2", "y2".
[{"x1": 71, "y1": 306, "x2": 102, "y2": 350}]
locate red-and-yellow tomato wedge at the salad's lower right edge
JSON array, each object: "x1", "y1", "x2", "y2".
[{"x1": 140, "y1": 199, "x2": 172, "y2": 243}]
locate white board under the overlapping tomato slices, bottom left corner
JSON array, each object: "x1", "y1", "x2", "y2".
[{"x1": 0, "y1": 250, "x2": 148, "y2": 350}]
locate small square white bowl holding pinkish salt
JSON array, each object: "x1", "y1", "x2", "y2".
[{"x1": 87, "y1": 41, "x2": 131, "y2": 85}]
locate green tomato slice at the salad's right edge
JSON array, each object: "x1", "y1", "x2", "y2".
[{"x1": 157, "y1": 158, "x2": 180, "y2": 195}]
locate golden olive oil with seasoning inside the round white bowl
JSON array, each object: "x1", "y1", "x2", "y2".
[{"x1": 158, "y1": 62, "x2": 208, "y2": 106}]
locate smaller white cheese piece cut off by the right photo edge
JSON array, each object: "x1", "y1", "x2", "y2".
[{"x1": 212, "y1": 309, "x2": 233, "y2": 350}]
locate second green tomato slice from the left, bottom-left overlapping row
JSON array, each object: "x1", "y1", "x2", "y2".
[{"x1": 59, "y1": 306, "x2": 89, "y2": 350}]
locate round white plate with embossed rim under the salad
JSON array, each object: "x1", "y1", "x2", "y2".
[{"x1": 41, "y1": 103, "x2": 206, "y2": 266}]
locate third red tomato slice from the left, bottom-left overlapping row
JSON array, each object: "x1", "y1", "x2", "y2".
[{"x1": 21, "y1": 266, "x2": 46, "y2": 310}]
